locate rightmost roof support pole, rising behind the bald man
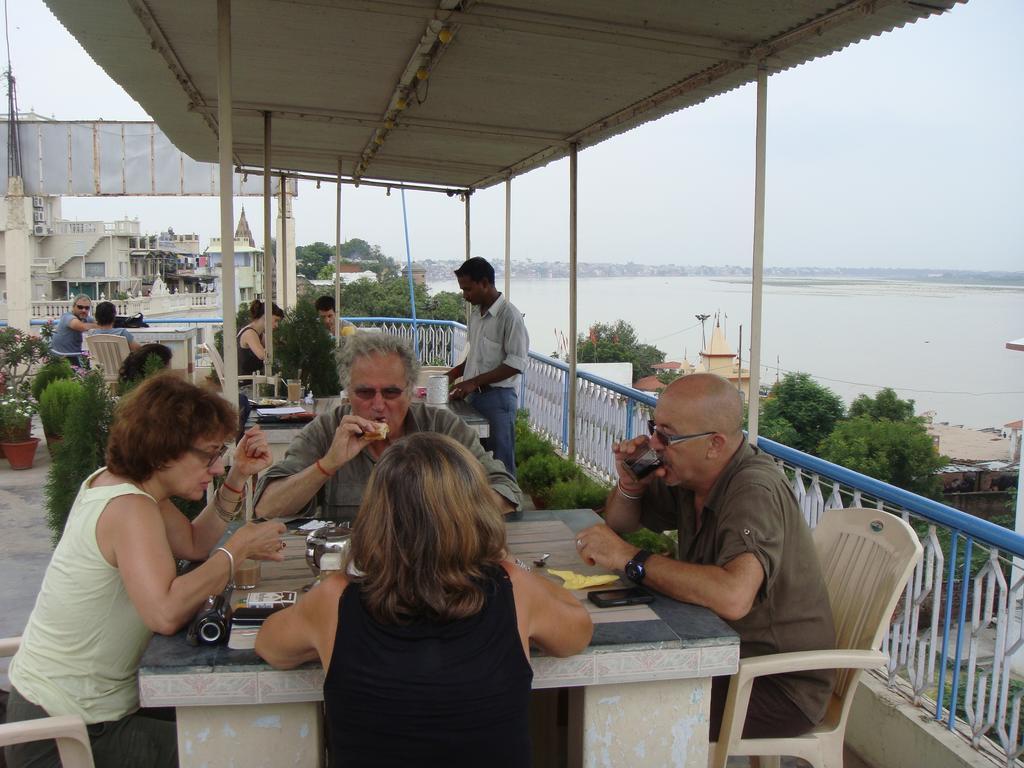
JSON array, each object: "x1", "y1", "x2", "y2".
[{"x1": 739, "y1": 62, "x2": 768, "y2": 445}]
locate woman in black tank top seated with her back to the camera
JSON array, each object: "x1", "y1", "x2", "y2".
[{"x1": 256, "y1": 436, "x2": 593, "y2": 768}]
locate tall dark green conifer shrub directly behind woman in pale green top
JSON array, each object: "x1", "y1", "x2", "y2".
[{"x1": 46, "y1": 371, "x2": 114, "y2": 546}]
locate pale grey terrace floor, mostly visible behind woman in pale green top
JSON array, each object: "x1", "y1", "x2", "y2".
[{"x1": 0, "y1": 434, "x2": 871, "y2": 768}]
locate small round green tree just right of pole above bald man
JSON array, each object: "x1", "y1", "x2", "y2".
[{"x1": 760, "y1": 373, "x2": 845, "y2": 455}]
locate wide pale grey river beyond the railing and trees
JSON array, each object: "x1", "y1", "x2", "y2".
[{"x1": 430, "y1": 278, "x2": 1024, "y2": 434}]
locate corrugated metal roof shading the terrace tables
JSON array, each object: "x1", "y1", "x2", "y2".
[{"x1": 46, "y1": 0, "x2": 957, "y2": 187}]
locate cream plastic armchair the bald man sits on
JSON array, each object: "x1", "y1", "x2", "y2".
[{"x1": 710, "y1": 509, "x2": 922, "y2": 768}]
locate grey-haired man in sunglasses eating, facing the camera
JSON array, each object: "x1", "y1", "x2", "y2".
[{"x1": 256, "y1": 334, "x2": 521, "y2": 522}]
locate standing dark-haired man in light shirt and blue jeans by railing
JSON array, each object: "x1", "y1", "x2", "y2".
[{"x1": 447, "y1": 257, "x2": 529, "y2": 477}]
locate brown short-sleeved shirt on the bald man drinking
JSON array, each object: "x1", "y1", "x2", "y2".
[{"x1": 640, "y1": 442, "x2": 836, "y2": 723}]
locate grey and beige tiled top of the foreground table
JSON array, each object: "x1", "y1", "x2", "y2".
[{"x1": 139, "y1": 510, "x2": 739, "y2": 707}]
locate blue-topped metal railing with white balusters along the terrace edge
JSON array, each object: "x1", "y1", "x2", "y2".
[{"x1": 9, "y1": 316, "x2": 1024, "y2": 765}]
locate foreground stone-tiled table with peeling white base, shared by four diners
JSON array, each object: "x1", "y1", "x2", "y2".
[{"x1": 139, "y1": 510, "x2": 739, "y2": 768}]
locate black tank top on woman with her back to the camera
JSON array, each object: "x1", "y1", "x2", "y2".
[{"x1": 324, "y1": 566, "x2": 534, "y2": 768}]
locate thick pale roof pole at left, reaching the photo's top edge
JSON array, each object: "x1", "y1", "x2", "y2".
[{"x1": 217, "y1": 0, "x2": 239, "y2": 406}]
